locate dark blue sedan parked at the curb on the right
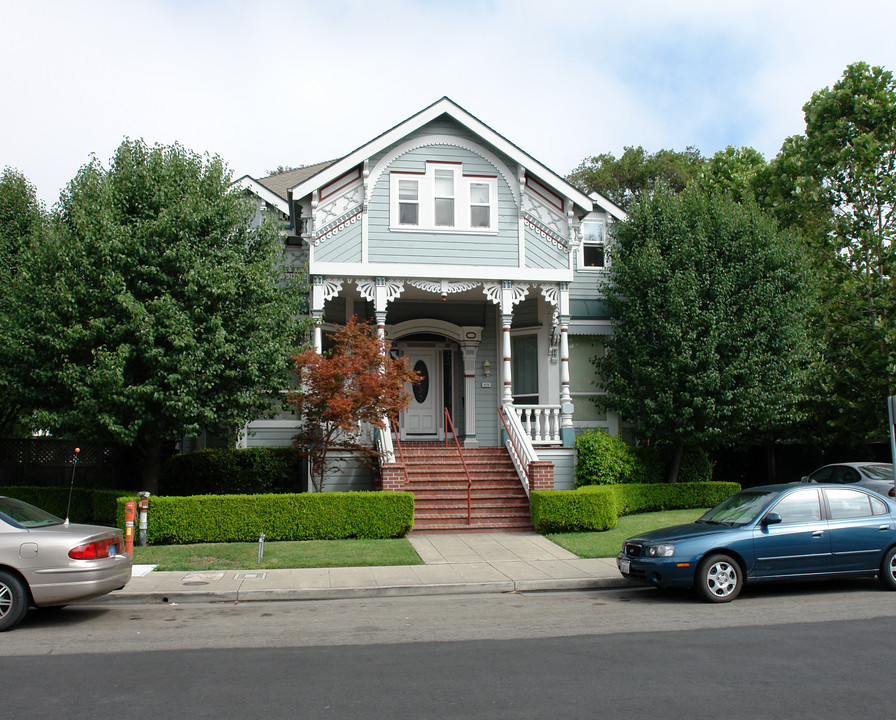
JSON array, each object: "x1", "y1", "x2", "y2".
[{"x1": 616, "y1": 484, "x2": 896, "y2": 602}]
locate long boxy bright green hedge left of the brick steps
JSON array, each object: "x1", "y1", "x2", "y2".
[{"x1": 118, "y1": 492, "x2": 414, "y2": 545}]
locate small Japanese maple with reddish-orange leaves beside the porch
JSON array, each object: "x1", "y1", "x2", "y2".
[{"x1": 287, "y1": 317, "x2": 420, "y2": 492}]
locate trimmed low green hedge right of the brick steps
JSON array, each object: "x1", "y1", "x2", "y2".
[{"x1": 530, "y1": 482, "x2": 740, "y2": 534}]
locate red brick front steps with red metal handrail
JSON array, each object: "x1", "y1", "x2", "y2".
[{"x1": 402, "y1": 443, "x2": 532, "y2": 533}]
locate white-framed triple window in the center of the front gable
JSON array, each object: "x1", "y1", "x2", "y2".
[{"x1": 389, "y1": 162, "x2": 498, "y2": 233}]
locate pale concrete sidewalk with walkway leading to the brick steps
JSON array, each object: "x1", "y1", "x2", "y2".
[{"x1": 103, "y1": 532, "x2": 630, "y2": 603}]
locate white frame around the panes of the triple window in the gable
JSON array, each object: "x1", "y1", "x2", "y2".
[{"x1": 389, "y1": 161, "x2": 498, "y2": 235}]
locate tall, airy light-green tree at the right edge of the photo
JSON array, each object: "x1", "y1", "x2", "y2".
[{"x1": 765, "y1": 62, "x2": 896, "y2": 444}]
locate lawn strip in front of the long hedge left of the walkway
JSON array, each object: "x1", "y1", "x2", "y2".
[{"x1": 134, "y1": 538, "x2": 423, "y2": 570}]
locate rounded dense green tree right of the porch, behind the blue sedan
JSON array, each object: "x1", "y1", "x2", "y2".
[{"x1": 595, "y1": 185, "x2": 807, "y2": 481}]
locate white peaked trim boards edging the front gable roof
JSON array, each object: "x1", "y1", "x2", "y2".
[{"x1": 289, "y1": 97, "x2": 596, "y2": 210}]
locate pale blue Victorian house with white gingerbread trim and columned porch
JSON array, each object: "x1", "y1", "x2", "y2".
[{"x1": 237, "y1": 98, "x2": 624, "y2": 528}]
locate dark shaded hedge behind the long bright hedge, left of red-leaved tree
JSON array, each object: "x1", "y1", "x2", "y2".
[{"x1": 159, "y1": 447, "x2": 304, "y2": 497}]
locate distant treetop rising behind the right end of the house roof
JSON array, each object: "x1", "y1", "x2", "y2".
[{"x1": 568, "y1": 146, "x2": 705, "y2": 210}]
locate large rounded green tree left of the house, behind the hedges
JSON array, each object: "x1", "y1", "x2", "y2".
[{"x1": 7, "y1": 140, "x2": 306, "y2": 491}]
